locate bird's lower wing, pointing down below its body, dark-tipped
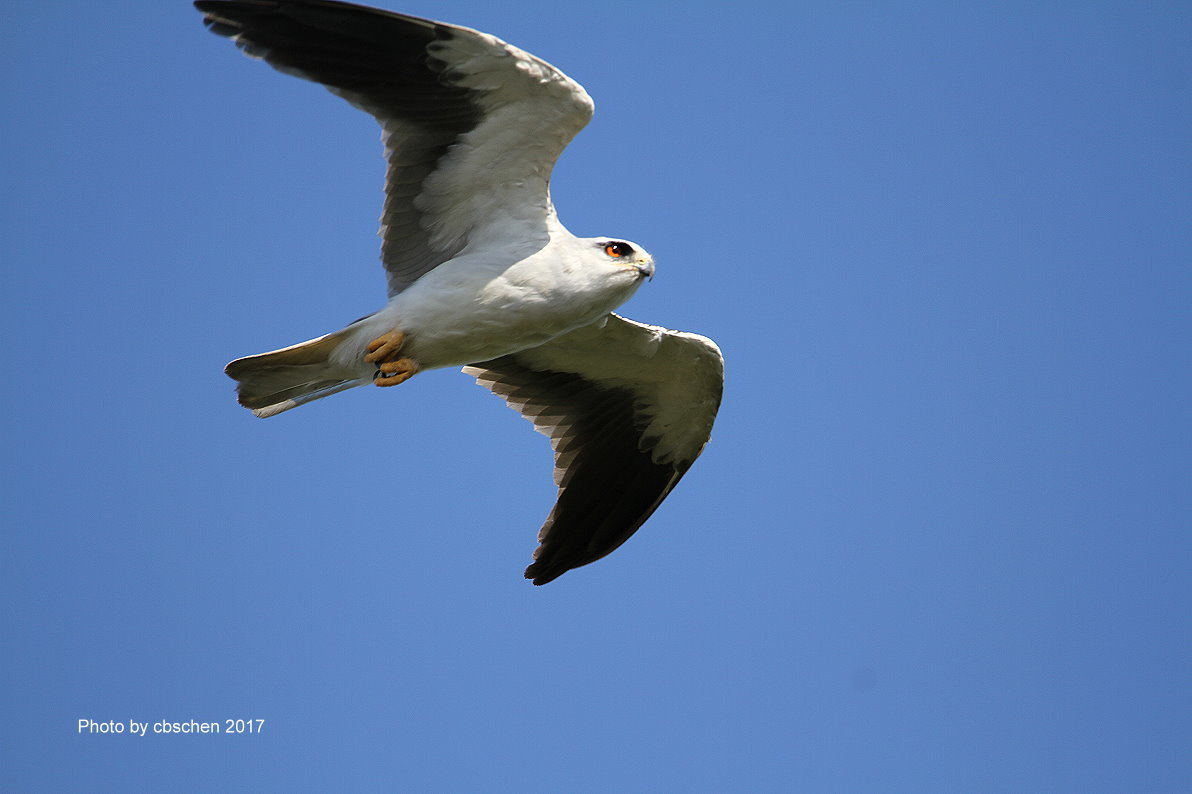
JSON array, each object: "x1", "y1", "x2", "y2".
[{"x1": 464, "y1": 315, "x2": 725, "y2": 584}]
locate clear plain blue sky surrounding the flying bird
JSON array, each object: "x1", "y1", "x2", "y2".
[{"x1": 0, "y1": 0, "x2": 1192, "y2": 792}]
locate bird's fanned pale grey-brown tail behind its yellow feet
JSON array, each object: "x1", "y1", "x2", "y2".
[{"x1": 224, "y1": 327, "x2": 367, "y2": 417}]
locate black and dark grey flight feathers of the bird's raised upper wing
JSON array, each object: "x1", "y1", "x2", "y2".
[{"x1": 194, "y1": 0, "x2": 483, "y2": 294}]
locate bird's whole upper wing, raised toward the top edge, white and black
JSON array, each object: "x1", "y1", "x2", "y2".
[{"x1": 194, "y1": 0, "x2": 592, "y2": 296}]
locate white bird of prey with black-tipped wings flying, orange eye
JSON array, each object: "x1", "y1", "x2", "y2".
[{"x1": 194, "y1": 0, "x2": 724, "y2": 584}]
